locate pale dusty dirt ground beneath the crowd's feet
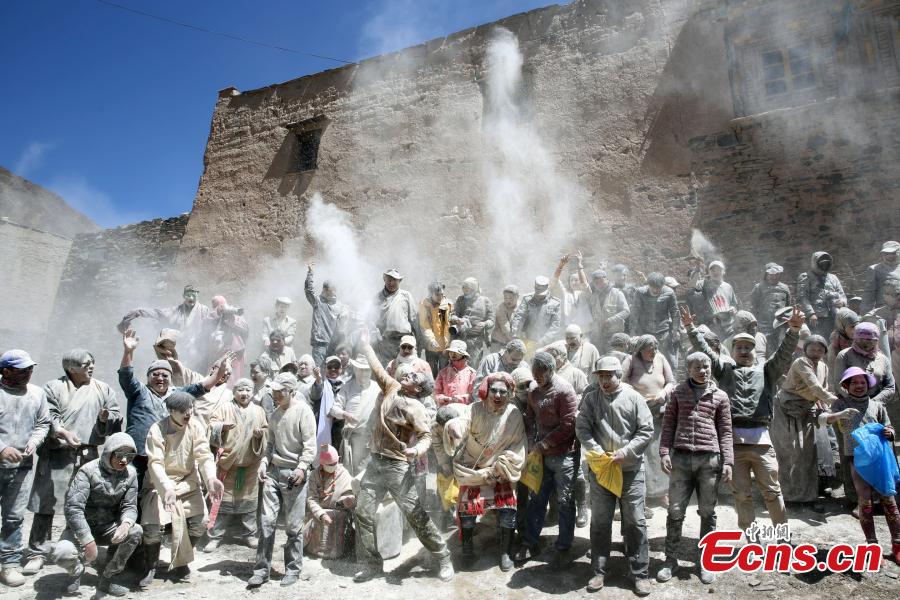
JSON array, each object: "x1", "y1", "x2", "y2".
[{"x1": 0, "y1": 488, "x2": 900, "y2": 600}]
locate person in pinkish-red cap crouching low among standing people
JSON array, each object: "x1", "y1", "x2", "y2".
[{"x1": 303, "y1": 444, "x2": 356, "y2": 559}]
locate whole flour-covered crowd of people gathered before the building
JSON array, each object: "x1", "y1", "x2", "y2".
[{"x1": 0, "y1": 241, "x2": 900, "y2": 596}]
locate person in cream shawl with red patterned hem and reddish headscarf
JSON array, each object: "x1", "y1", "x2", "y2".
[{"x1": 453, "y1": 373, "x2": 525, "y2": 571}]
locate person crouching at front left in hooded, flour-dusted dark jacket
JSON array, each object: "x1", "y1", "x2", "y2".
[{"x1": 49, "y1": 432, "x2": 144, "y2": 596}]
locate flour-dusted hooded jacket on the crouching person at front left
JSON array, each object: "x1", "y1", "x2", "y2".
[{"x1": 65, "y1": 432, "x2": 138, "y2": 547}]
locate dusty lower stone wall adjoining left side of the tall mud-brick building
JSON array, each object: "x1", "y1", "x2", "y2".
[{"x1": 42, "y1": 214, "x2": 188, "y2": 389}]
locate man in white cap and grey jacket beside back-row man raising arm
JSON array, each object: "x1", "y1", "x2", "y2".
[{"x1": 374, "y1": 268, "x2": 419, "y2": 364}]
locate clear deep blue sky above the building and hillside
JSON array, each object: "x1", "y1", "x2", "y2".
[{"x1": 0, "y1": 0, "x2": 562, "y2": 227}]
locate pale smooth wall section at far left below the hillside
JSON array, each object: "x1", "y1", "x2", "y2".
[{"x1": 0, "y1": 219, "x2": 72, "y2": 361}]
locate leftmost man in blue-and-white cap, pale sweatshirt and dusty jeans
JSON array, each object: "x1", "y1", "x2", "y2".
[{"x1": 0, "y1": 350, "x2": 50, "y2": 587}]
